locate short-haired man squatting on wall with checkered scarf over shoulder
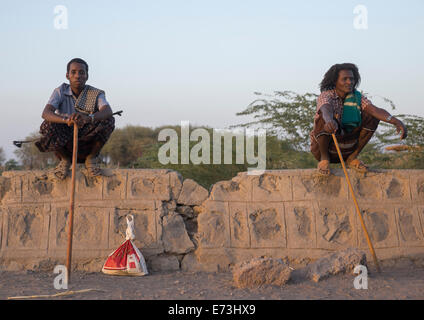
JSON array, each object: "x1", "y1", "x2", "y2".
[{"x1": 35, "y1": 58, "x2": 115, "y2": 179}]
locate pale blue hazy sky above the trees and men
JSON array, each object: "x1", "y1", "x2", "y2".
[{"x1": 0, "y1": 0, "x2": 424, "y2": 158}]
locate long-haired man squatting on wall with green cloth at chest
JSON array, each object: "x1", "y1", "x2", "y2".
[{"x1": 310, "y1": 63, "x2": 407, "y2": 175}]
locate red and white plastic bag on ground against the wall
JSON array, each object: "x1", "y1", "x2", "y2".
[{"x1": 102, "y1": 215, "x2": 148, "y2": 276}]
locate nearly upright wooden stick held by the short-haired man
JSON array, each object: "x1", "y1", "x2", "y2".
[{"x1": 66, "y1": 122, "x2": 78, "y2": 283}]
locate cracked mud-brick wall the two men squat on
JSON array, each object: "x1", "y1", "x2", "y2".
[{"x1": 0, "y1": 169, "x2": 424, "y2": 271}]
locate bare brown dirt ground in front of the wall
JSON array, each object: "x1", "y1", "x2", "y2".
[{"x1": 0, "y1": 263, "x2": 424, "y2": 300}]
